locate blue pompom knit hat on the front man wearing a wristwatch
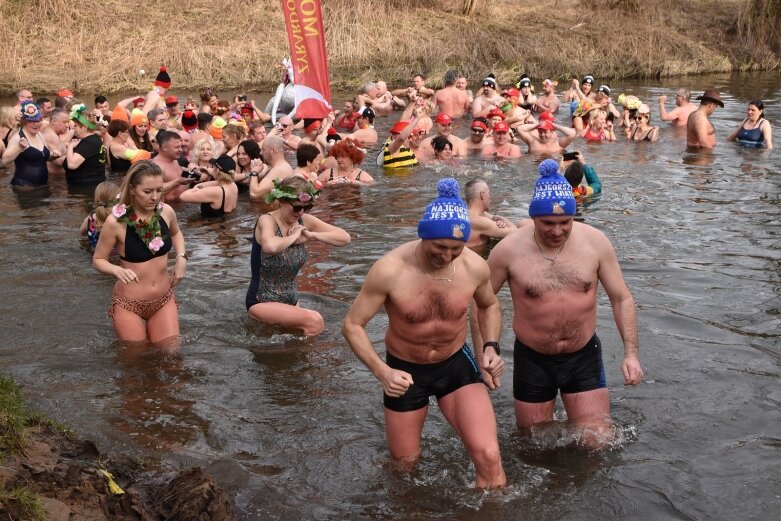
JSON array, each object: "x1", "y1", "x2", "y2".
[{"x1": 418, "y1": 177, "x2": 470, "y2": 242}]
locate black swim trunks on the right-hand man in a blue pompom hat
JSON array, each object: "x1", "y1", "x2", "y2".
[{"x1": 513, "y1": 333, "x2": 607, "y2": 403}]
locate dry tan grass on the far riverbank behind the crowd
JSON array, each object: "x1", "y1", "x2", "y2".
[{"x1": 0, "y1": 0, "x2": 781, "y2": 93}]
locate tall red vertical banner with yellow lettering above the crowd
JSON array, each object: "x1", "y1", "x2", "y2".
[{"x1": 281, "y1": 0, "x2": 331, "y2": 118}]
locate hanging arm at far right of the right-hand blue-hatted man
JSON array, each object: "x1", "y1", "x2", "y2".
[{"x1": 593, "y1": 230, "x2": 643, "y2": 385}]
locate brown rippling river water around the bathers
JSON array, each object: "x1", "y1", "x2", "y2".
[{"x1": 0, "y1": 74, "x2": 781, "y2": 521}]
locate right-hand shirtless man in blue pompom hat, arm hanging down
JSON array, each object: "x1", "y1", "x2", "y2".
[{"x1": 488, "y1": 159, "x2": 643, "y2": 447}]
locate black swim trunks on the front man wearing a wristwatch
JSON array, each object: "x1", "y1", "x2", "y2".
[{"x1": 383, "y1": 344, "x2": 483, "y2": 412}]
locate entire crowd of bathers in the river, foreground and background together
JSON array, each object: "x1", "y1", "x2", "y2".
[{"x1": 0, "y1": 68, "x2": 773, "y2": 487}]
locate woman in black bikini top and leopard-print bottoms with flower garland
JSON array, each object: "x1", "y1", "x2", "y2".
[{"x1": 92, "y1": 160, "x2": 187, "y2": 344}]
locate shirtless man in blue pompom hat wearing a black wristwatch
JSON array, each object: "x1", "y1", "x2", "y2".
[{"x1": 342, "y1": 179, "x2": 506, "y2": 488}]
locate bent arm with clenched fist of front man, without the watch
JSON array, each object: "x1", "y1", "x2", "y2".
[{"x1": 342, "y1": 259, "x2": 414, "y2": 397}]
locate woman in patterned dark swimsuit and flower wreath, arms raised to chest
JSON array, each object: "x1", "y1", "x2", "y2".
[{"x1": 246, "y1": 176, "x2": 350, "y2": 336}]
